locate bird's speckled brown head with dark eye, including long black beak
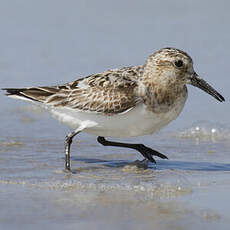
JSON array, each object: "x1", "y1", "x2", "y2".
[{"x1": 145, "y1": 48, "x2": 224, "y2": 102}]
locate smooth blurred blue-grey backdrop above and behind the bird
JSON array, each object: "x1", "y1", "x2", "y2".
[{"x1": 0, "y1": 0, "x2": 230, "y2": 128}]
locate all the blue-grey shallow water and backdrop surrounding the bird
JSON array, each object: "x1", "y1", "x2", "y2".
[{"x1": 0, "y1": 0, "x2": 230, "y2": 230}]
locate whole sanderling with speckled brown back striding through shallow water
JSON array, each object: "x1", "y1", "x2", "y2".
[{"x1": 3, "y1": 48, "x2": 224, "y2": 171}]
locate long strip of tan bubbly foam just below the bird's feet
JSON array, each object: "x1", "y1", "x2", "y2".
[{"x1": 0, "y1": 162, "x2": 192, "y2": 200}]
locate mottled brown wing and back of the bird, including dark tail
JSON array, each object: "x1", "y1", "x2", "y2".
[{"x1": 6, "y1": 66, "x2": 142, "y2": 115}]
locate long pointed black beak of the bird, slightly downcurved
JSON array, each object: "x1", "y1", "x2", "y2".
[{"x1": 189, "y1": 73, "x2": 225, "y2": 102}]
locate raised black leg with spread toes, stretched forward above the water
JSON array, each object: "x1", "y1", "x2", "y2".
[{"x1": 97, "y1": 137, "x2": 168, "y2": 163}]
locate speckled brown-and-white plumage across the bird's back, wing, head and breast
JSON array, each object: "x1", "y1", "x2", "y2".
[{"x1": 1, "y1": 48, "x2": 196, "y2": 115}]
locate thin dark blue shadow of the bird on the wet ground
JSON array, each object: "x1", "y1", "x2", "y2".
[{"x1": 71, "y1": 157, "x2": 230, "y2": 171}]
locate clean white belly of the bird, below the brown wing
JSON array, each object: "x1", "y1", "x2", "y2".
[{"x1": 49, "y1": 95, "x2": 186, "y2": 137}]
